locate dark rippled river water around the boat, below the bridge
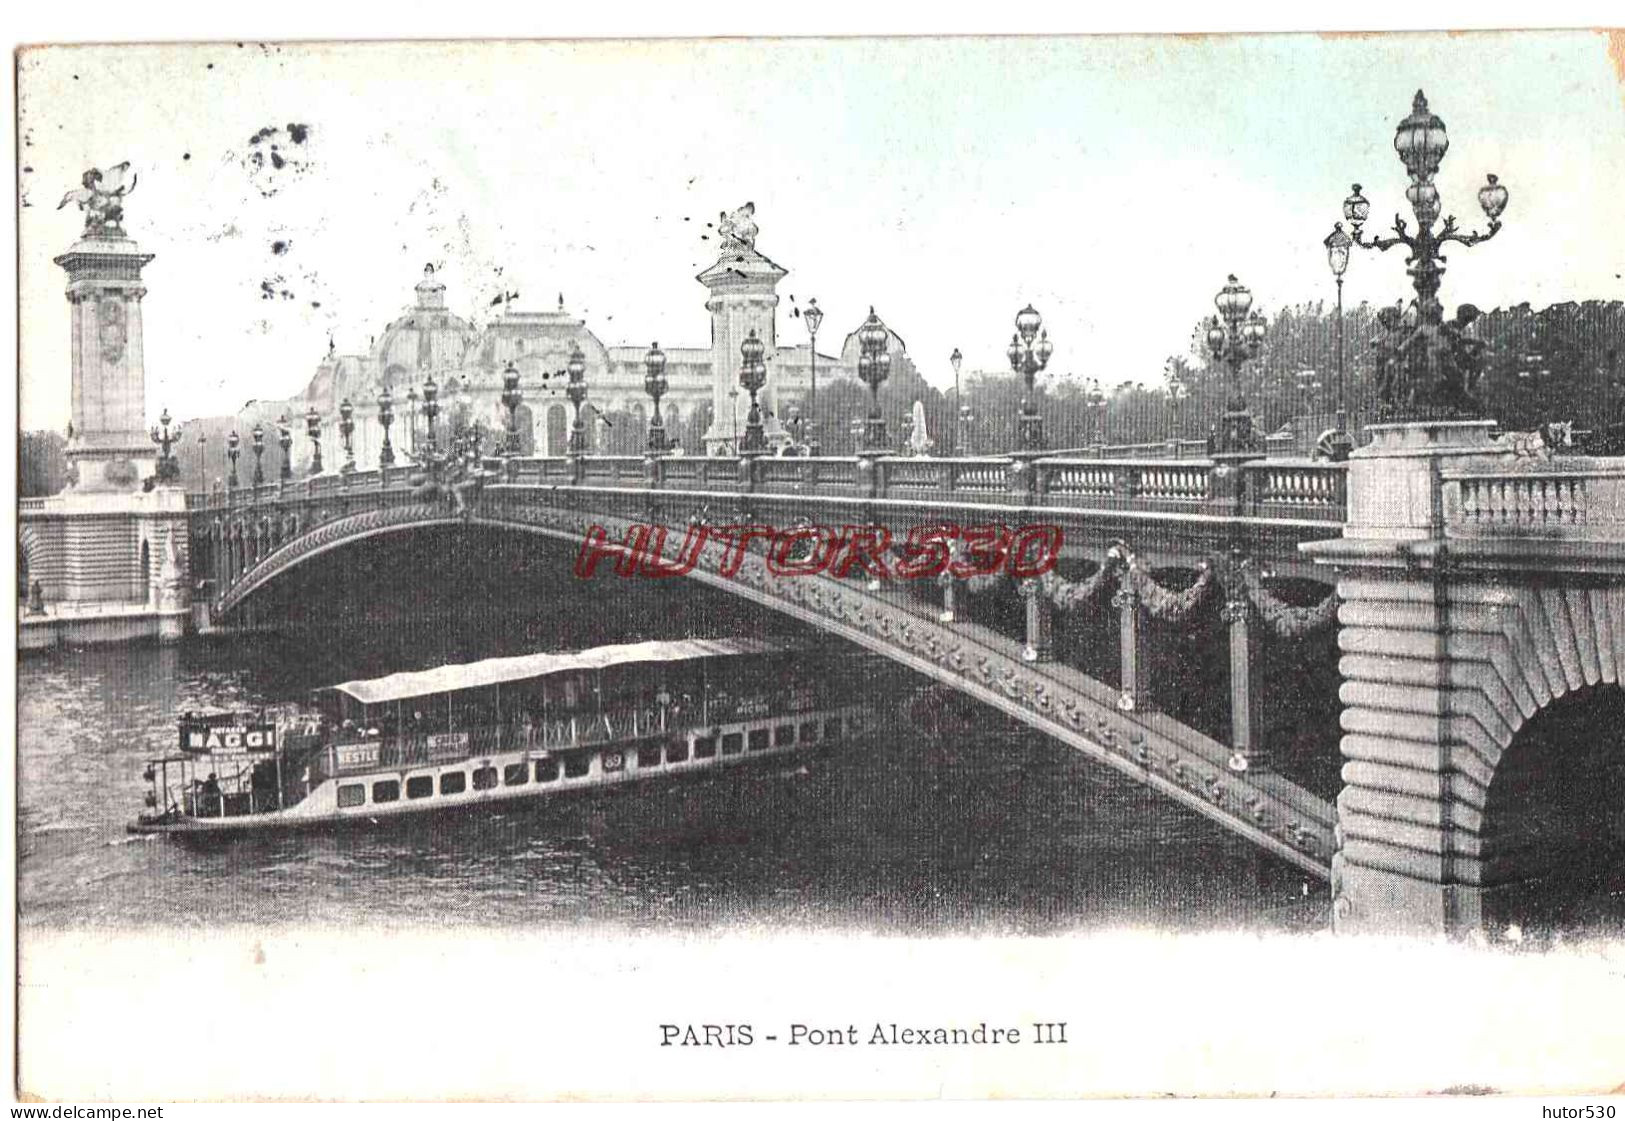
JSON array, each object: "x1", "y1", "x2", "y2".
[{"x1": 18, "y1": 635, "x2": 1328, "y2": 934}]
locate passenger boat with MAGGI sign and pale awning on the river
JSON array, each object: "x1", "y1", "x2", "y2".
[{"x1": 128, "y1": 638, "x2": 874, "y2": 835}]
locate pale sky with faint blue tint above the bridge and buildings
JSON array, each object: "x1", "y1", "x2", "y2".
[{"x1": 18, "y1": 31, "x2": 1625, "y2": 429}]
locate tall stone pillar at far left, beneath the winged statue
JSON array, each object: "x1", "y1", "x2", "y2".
[{"x1": 55, "y1": 232, "x2": 158, "y2": 494}]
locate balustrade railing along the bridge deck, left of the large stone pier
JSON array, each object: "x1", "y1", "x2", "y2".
[{"x1": 187, "y1": 455, "x2": 1347, "y2": 522}]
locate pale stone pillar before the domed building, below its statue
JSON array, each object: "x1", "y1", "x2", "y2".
[{"x1": 696, "y1": 240, "x2": 788, "y2": 455}]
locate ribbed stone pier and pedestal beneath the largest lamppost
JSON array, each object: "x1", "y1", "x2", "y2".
[{"x1": 1303, "y1": 421, "x2": 1511, "y2": 934}]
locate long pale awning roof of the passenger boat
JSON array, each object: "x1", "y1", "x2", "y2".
[{"x1": 316, "y1": 638, "x2": 800, "y2": 705}]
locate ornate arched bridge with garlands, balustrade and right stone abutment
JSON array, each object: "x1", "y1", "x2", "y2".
[{"x1": 189, "y1": 422, "x2": 1625, "y2": 933}]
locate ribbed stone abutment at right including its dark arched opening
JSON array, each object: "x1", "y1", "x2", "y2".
[{"x1": 1333, "y1": 573, "x2": 1625, "y2": 933}]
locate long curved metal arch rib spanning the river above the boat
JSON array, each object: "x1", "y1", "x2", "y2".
[{"x1": 215, "y1": 491, "x2": 1333, "y2": 876}]
